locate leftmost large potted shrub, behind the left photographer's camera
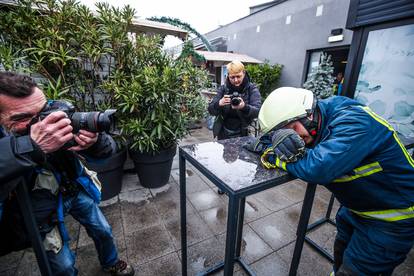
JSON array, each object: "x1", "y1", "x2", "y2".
[{"x1": 0, "y1": 0, "x2": 134, "y2": 199}]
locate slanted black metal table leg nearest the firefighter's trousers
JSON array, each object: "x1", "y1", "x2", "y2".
[{"x1": 289, "y1": 183, "x2": 316, "y2": 276}]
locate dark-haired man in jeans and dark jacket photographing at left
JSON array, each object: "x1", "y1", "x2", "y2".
[{"x1": 0, "y1": 72, "x2": 134, "y2": 275}]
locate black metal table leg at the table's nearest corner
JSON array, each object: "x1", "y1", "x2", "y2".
[{"x1": 224, "y1": 194, "x2": 240, "y2": 276}]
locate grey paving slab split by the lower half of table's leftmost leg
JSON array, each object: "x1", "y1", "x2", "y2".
[{"x1": 165, "y1": 211, "x2": 214, "y2": 250}]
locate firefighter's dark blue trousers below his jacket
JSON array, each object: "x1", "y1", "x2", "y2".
[{"x1": 334, "y1": 207, "x2": 414, "y2": 276}]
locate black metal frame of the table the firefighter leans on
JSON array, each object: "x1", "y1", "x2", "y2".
[{"x1": 179, "y1": 148, "x2": 326, "y2": 276}]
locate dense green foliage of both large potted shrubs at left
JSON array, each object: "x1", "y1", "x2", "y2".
[{"x1": 0, "y1": 0, "x2": 208, "y2": 151}]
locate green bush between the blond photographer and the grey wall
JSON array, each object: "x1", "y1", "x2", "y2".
[{"x1": 245, "y1": 61, "x2": 283, "y2": 99}]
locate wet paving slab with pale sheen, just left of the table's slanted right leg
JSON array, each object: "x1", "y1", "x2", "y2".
[{"x1": 249, "y1": 212, "x2": 296, "y2": 250}]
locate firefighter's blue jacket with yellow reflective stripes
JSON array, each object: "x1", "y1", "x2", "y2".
[{"x1": 286, "y1": 97, "x2": 414, "y2": 221}]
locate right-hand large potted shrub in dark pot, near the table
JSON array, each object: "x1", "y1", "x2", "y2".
[{"x1": 106, "y1": 35, "x2": 208, "y2": 188}]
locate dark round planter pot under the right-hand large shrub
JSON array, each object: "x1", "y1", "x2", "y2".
[{"x1": 129, "y1": 145, "x2": 177, "y2": 188}]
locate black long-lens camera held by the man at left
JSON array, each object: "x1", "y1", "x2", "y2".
[{"x1": 30, "y1": 100, "x2": 116, "y2": 148}]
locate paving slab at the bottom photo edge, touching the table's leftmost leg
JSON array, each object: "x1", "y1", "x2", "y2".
[{"x1": 135, "y1": 252, "x2": 181, "y2": 276}]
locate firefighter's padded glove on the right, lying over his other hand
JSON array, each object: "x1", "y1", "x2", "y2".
[{"x1": 272, "y1": 129, "x2": 305, "y2": 163}]
